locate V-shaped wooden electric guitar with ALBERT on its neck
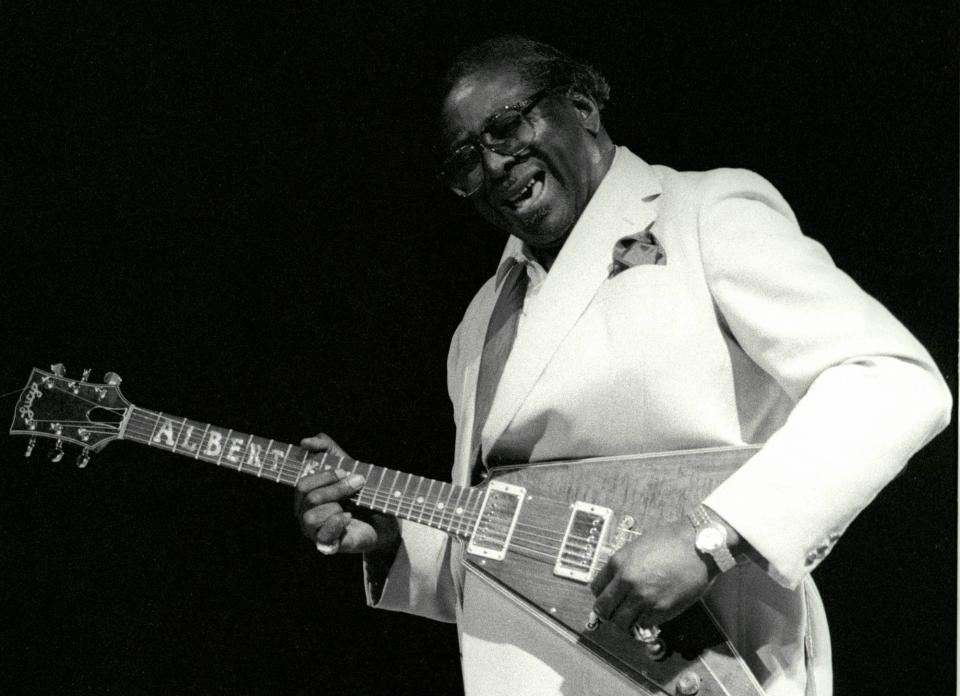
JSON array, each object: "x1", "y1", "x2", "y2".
[{"x1": 10, "y1": 365, "x2": 763, "y2": 696}]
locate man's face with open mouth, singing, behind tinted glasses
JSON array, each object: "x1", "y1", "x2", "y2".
[{"x1": 443, "y1": 68, "x2": 603, "y2": 249}]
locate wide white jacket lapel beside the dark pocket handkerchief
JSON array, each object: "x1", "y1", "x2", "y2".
[{"x1": 481, "y1": 148, "x2": 660, "y2": 452}]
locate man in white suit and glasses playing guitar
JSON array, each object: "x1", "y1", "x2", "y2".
[{"x1": 296, "y1": 37, "x2": 951, "y2": 695}]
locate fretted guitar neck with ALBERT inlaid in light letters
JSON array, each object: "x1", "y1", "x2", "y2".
[{"x1": 119, "y1": 405, "x2": 484, "y2": 539}]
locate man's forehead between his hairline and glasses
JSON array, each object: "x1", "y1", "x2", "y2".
[{"x1": 442, "y1": 67, "x2": 532, "y2": 144}]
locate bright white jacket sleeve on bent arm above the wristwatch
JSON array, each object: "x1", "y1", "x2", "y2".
[{"x1": 700, "y1": 170, "x2": 951, "y2": 587}]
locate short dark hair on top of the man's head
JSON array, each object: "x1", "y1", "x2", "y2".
[{"x1": 440, "y1": 35, "x2": 610, "y2": 109}]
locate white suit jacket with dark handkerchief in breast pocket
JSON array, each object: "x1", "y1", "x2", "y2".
[{"x1": 369, "y1": 148, "x2": 951, "y2": 696}]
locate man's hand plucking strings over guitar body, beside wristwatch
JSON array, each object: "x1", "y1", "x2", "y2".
[{"x1": 590, "y1": 520, "x2": 717, "y2": 632}]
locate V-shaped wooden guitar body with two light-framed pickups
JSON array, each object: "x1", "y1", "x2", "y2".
[{"x1": 464, "y1": 447, "x2": 763, "y2": 696}]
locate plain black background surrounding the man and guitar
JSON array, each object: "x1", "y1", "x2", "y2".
[{"x1": 0, "y1": 2, "x2": 958, "y2": 695}]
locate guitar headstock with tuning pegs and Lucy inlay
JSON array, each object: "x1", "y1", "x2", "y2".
[{"x1": 10, "y1": 363, "x2": 130, "y2": 468}]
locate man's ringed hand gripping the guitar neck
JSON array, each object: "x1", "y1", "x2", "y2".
[{"x1": 294, "y1": 433, "x2": 400, "y2": 554}]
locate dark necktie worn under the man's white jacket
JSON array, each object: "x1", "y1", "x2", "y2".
[{"x1": 473, "y1": 262, "x2": 527, "y2": 462}]
